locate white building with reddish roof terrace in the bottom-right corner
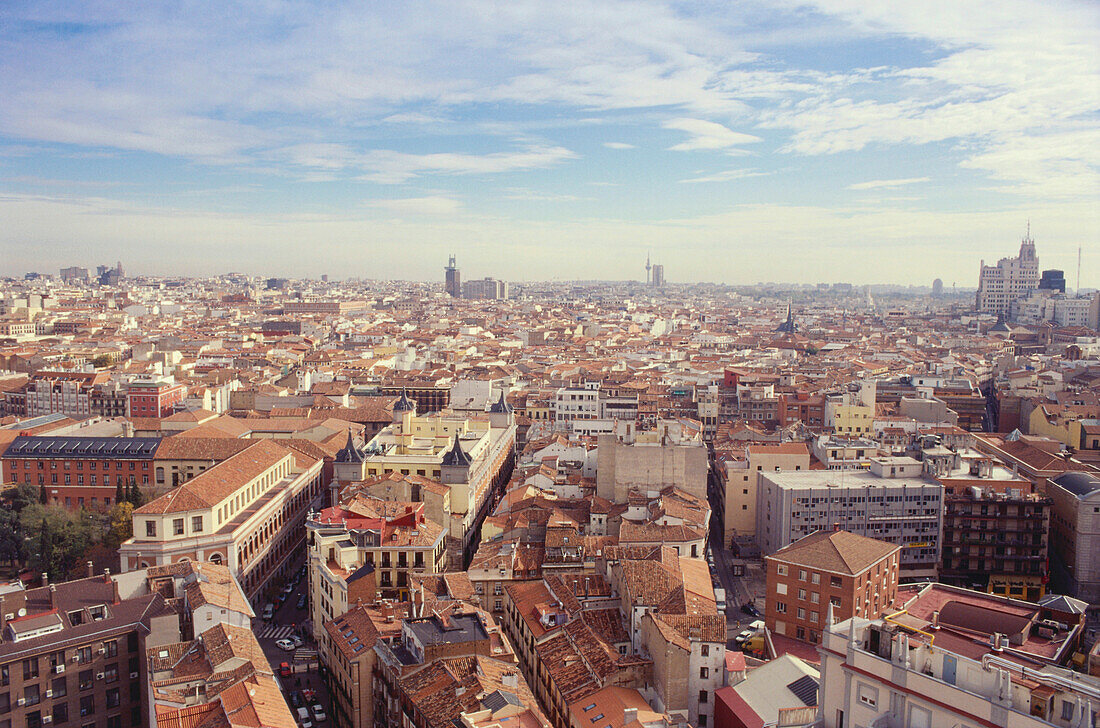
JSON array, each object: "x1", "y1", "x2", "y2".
[{"x1": 818, "y1": 584, "x2": 1100, "y2": 728}]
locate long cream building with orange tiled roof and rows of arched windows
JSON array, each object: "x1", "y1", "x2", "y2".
[{"x1": 119, "y1": 440, "x2": 325, "y2": 603}]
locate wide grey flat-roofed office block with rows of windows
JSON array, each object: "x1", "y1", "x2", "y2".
[{"x1": 757, "y1": 457, "x2": 944, "y2": 577}]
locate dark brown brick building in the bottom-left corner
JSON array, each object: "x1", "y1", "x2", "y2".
[{"x1": 0, "y1": 574, "x2": 179, "y2": 728}]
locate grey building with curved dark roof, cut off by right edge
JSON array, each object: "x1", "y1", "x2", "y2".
[{"x1": 1046, "y1": 472, "x2": 1100, "y2": 604}]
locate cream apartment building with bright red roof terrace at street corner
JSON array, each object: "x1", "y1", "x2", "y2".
[{"x1": 306, "y1": 496, "x2": 447, "y2": 637}]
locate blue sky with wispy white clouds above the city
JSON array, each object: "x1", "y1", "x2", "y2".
[{"x1": 0, "y1": 0, "x2": 1100, "y2": 287}]
